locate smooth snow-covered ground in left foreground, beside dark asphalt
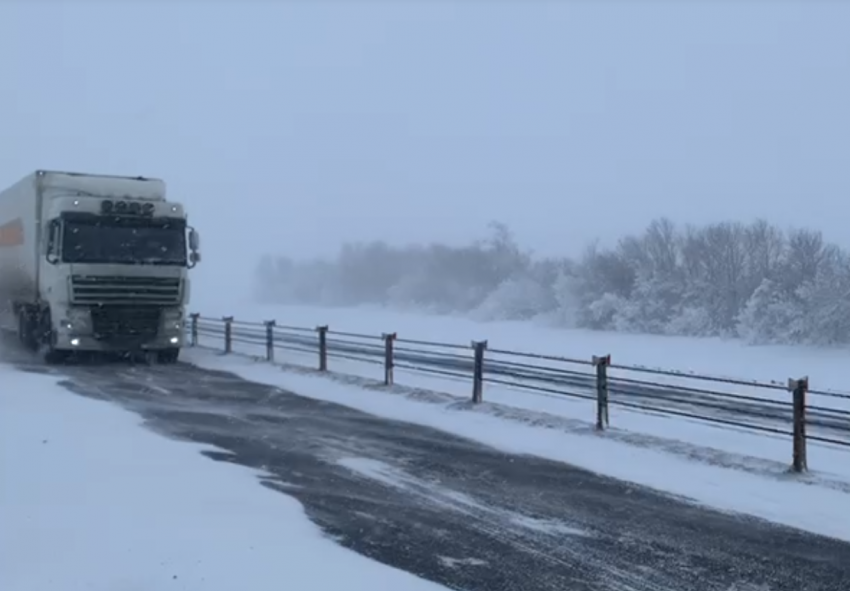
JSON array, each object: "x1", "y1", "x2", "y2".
[{"x1": 0, "y1": 365, "x2": 444, "y2": 591}]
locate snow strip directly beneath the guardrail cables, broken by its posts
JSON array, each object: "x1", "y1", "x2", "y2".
[{"x1": 187, "y1": 336, "x2": 850, "y2": 490}]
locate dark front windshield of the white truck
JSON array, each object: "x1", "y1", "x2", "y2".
[{"x1": 62, "y1": 216, "x2": 186, "y2": 265}]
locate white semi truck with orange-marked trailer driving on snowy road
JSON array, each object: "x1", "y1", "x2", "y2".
[{"x1": 0, "y1": 170, "x2": 201, "y2": 363}]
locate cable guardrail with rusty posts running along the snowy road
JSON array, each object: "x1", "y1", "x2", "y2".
[{"x1": 189, "y1": 314, "x2": 850, "y2": 472}]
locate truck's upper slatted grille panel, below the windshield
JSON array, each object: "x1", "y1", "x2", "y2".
[{"x1": 71, "y1": 275, "x2": 181, "y2": 306}]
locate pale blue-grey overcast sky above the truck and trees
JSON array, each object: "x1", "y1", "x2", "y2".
[{"x1": 0, "y1": 0, "x2": 850, "y2": 296}]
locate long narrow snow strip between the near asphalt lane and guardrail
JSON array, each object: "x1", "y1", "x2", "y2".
[{"x1": 186, "y1": 350, "x2": 850, "y2": 540}]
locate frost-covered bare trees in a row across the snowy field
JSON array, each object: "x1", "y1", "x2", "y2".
[{"x1": 256, "y1": 218, "x2": 850, "y2": 345}]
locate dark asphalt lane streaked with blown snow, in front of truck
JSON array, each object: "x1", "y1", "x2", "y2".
[{"x1": 7, "y1": 344, "x2": 850, "y2": 591}]
